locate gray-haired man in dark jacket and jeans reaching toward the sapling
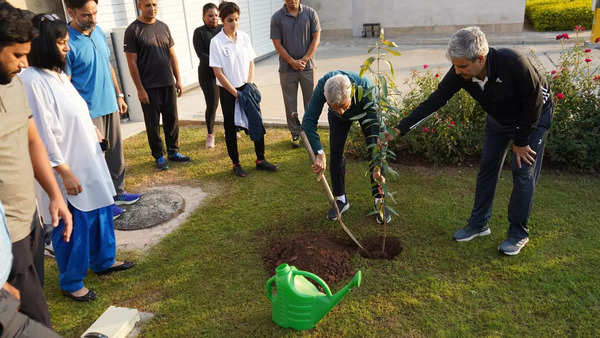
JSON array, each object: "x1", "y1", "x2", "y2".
[{"x1": 390, "y1": 27, "x2": 553, "y2": 255}]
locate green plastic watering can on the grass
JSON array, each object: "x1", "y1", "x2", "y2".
[{"x1": 267, "y1": 263, "x2": 362, "y2": 330}]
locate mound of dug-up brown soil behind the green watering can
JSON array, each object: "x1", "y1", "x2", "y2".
[{"x1": 264, "y1": 233, "x2": 356, "y2": 285}]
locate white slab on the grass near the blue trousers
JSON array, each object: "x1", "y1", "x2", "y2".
[{"x1": 81, "y1": 305, "x2": 140, "y2": 338}]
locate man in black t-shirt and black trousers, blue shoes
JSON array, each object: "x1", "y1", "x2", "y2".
[{"x1": 124, "y1": 0, "x2": 191, "y2": 170}]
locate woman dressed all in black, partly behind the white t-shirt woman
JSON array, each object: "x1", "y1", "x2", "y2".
[{"x1": 193, "y1": 2, "x2": 223, "y2": 148}]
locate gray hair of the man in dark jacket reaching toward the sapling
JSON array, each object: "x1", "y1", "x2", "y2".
[{"x1": 446, "y1": 26, "x2": 489, "y2": 61}]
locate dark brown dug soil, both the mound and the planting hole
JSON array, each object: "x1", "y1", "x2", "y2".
[{"x1": 264, "y1": 233, "x2": 402, "y2": 285}]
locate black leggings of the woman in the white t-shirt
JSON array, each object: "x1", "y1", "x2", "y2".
[{"x1": 219, "y1": 85, "x2": 265, "y2": 165}]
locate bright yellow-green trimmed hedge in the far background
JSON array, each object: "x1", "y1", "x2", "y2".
[{"x1": 525, "y1": 0, "x2": 594, "y2": 31}]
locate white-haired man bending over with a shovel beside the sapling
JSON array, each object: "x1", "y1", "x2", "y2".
[{"x1": 302, "y1": 70, "x2": 392, "y2": 224}]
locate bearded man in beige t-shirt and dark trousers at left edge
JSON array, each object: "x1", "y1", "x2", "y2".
[{"x1": 0, "y1": 2, "x2": 73, "y2": 327}]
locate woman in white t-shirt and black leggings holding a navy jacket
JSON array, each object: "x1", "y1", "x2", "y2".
[{"x1": 209, "y1": 1, "x2": 277, "y2": 177}]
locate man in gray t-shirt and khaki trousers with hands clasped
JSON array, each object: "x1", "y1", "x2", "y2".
[{"x1": 271, "y1": 0, "x2": 321, "y2": 148}]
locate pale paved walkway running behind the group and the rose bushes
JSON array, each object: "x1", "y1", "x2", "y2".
[{"x1": 121, "y1": 32, "x2": 600, "y2": 138}]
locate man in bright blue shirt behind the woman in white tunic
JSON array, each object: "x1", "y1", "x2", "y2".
[{"x1": 66, "y1": 0, "x2": 140, "y2": 217}]
